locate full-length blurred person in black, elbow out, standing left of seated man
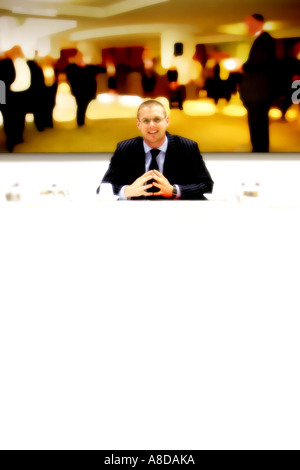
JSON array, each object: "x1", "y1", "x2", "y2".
[{"x1": 66, "y1": 51, "x2": 105, "y2": 126}]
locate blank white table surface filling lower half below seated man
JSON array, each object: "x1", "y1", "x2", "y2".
[{"x1": 0, "y1": 200, "x2": 300, "y2": 450}]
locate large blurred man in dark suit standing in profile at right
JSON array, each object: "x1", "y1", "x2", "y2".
[{"x1": 240, "y1": 14, "x2": 276, "y2": 152}]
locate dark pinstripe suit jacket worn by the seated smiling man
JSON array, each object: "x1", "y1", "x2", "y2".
[{"x1": 102, "y1": 132, "x2": 213, "y2": 199}]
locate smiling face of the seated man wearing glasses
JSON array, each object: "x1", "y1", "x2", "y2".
[{"x1": 136, "y1": 105, "x2": 169, "y2": 148}]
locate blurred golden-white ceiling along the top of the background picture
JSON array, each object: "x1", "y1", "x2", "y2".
[{"x1": 0, "y1": 0, "x2": 300, "y2": 53}]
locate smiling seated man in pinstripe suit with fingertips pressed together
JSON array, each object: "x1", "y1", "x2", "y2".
[{"x1": 97, "y1": 100, "x2": 213, "y2": 200}]
